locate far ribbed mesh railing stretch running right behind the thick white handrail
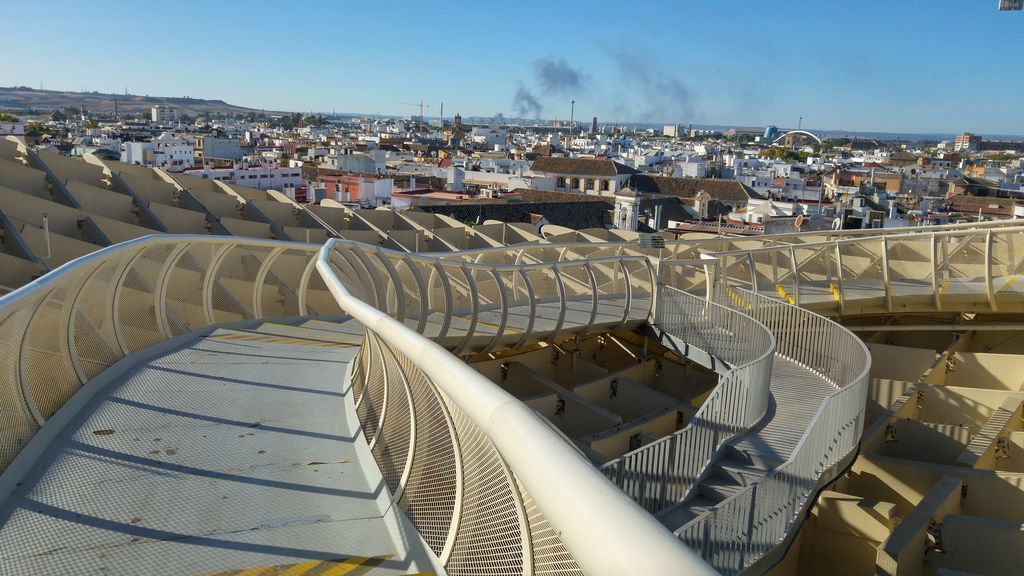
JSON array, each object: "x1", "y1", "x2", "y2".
[{"x1": 326, "y1": 240, "x2": 655, "y2": 355}]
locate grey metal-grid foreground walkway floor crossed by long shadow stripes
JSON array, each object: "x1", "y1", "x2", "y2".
[{"x1": 0, "y1": 321, "x2": 440, "y2": 574}]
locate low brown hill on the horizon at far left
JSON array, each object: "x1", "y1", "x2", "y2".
[{"x1": 0, "y1": 86, "x2": 271, "y2": 116}]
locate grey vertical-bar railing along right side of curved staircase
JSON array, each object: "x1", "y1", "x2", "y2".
[{"x1": 677, "y1": 285, "x2": 870, "y2": 574}]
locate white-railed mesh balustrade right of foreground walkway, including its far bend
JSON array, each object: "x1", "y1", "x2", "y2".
[{"x1": 316, "y1": 235, "x2": 707, "y2": 575}]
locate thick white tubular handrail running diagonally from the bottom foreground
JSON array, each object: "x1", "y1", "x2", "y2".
[{"x1": 316, "y1": 240, "x2": 712, "y2": 575}]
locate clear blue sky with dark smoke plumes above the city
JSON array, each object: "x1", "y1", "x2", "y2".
[{"x1": 0, "y1": 0, "x2": 1024, "y2": 134}]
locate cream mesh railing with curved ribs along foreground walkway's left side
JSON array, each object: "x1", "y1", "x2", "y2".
[{"x1": 0, "y1": 236, "x2": 327, "y2": 470}]
